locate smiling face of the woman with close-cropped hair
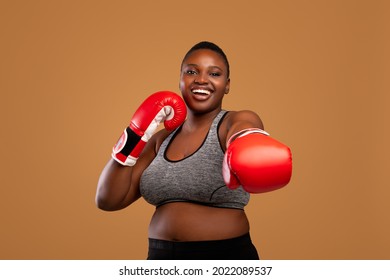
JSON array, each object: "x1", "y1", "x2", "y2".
[{"x1": 180, "y1": 49, "x2": 230, "y2": 113}]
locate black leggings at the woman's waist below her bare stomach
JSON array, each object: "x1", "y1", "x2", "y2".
[{"x1": 147, "y1": 233, "x2": 259, "y2": 260}]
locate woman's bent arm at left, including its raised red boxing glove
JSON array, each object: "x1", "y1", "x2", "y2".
[{"x1": 96, "y1": 92, "x2": 186, "y2": 211}]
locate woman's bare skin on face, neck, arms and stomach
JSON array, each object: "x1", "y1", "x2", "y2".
[{"x1": 96, "y1": 49, "x2": 263, "y2": 241}]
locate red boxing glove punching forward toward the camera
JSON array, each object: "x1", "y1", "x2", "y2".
[{"x1": 222, "y1": 128, "x2": 292, "y2": 193}]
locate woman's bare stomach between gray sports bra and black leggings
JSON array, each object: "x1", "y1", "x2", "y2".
[{"x1": 149, "y1": 202, "x2": 249, "y2": 241}]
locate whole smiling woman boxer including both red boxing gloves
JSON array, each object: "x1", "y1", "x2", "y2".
[{"x1": 96, "y1": 42, "x2": 291, "y2": 259}]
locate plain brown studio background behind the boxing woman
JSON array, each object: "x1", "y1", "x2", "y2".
[{"x1": 0, "y1": 0, "x2": 390, "y2": 259}]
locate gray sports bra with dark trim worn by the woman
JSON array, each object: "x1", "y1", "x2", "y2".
[{"x1": 140, "y1": 111, "x2": 249, "y2": 209}]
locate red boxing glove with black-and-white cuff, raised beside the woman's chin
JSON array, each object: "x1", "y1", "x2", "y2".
[{"x1": 111, "y1": 91, "x2": 187, "y2": 166}]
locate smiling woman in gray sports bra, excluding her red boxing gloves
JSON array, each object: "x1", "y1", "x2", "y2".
[{"x1": 96, "y1": 42, "x2": 290, "y2": 259}]
